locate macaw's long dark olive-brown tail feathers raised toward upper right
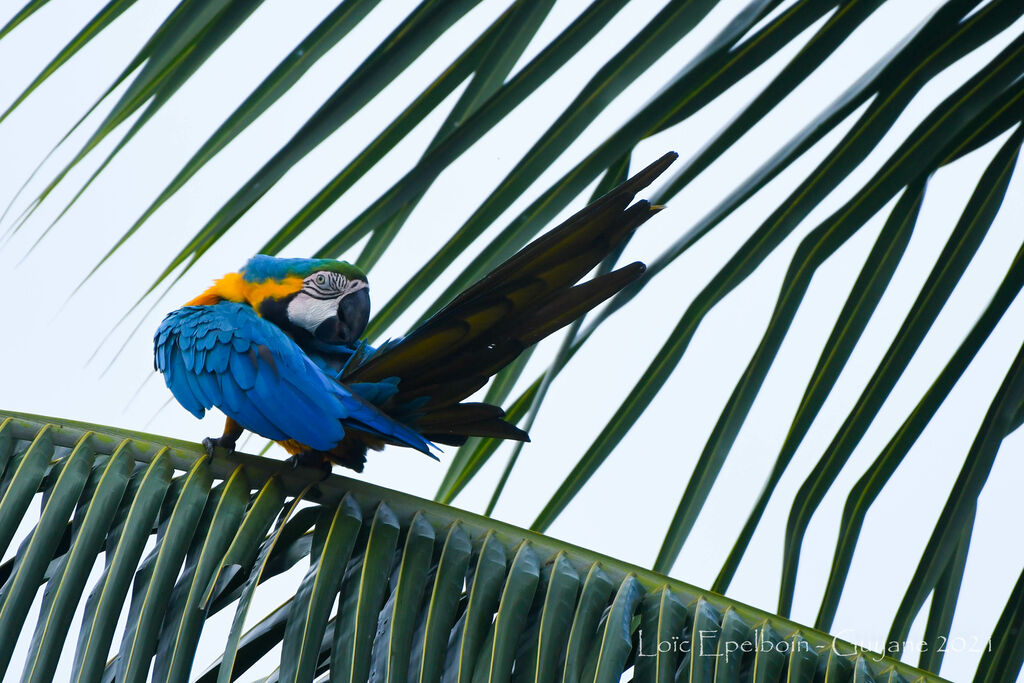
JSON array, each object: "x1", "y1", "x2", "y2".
[{"x1": 341, "y1": 153, "x2": 677, "y2": 445}]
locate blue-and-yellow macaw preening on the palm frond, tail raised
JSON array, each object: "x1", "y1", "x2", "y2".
[{"x1": 154, "y1": 153, "x2": 676, "y2": 472}]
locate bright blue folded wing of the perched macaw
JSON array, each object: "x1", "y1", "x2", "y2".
[{"x1": 154, "y1": 302, "x2": 432, "y2": 455}]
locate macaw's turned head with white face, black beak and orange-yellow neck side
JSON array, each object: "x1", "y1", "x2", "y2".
[{"x1": 189, "y1": 254, "x2": 370, "y2": 345}]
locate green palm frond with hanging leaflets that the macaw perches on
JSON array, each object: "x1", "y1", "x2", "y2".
[{"x1": 0, "y1": 413, "x2": 946, "y2": 682}]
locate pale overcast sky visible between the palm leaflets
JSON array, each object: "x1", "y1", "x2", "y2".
[{"x1": 0, "y1": 0, "x2": 1024, "y2": 680}]
